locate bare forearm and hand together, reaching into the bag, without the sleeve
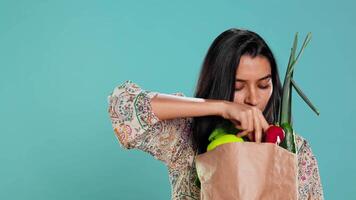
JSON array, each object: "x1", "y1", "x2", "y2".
[{"x1": 151, "y1": 93, "x2": 269, "y2": 142}]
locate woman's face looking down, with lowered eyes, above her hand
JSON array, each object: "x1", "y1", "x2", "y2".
[{"x1": 234, "y1": 55, "x2": 273, "y2": 111}]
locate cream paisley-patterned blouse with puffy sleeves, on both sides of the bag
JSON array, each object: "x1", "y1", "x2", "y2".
[{"x1": 108, "y1": 80, "x2": 324, "y2": 200}]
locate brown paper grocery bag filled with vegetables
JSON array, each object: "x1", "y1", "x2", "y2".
[{"x1": 195, "y1": 142, "x2": 298, "y2": 200}]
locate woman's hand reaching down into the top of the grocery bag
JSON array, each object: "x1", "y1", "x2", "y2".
[{"x1": 221, "y1": 101, "x2": 270, "y2": 143}]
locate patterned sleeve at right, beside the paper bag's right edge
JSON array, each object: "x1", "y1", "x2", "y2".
[{"x1": 298, "y1": 139, "x2": 324, "y2": 200}]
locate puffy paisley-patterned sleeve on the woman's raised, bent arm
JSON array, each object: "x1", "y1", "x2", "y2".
[{"x1": 108, "y1": 80, "x2": 193, "y2": 168}]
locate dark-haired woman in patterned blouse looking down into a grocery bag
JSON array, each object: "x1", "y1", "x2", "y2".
[{"x1": 108, "y1": 29, "x2": 323, "y2": 199}]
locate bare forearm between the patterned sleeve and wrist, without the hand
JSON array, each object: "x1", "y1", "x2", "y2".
[{"x1": 151, "y1": 93, "x2": 225, "y2": 120}]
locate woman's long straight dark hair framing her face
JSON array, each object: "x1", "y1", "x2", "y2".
[{"x1": 192, "y1": 28, "x2": 282, "y2": 154}]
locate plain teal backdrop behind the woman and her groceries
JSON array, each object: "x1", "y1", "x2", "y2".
[{"x1": 0, "y1": 0, "x2": 356, "y2": 200}]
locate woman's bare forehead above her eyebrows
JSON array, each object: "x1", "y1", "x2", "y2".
[{"x1": 236, "y1": 55, "x2": 271, "y2": 81}]
